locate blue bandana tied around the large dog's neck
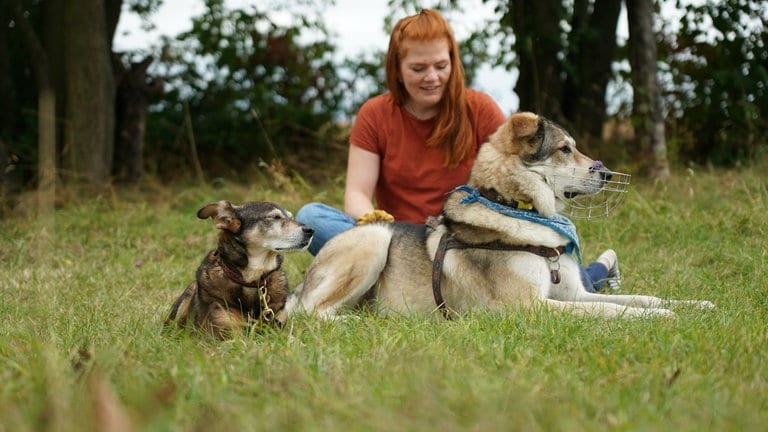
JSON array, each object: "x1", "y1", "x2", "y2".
[{"x1": 454, "y1": 185, "x2": 581, "y2": 263}]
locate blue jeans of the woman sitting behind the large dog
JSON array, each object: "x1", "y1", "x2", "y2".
[{"x1": 296, "y1": 203, "x2": 608, "y2": 292}]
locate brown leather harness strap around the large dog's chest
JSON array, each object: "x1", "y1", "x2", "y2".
[{"x1": 432, "y1": 234, "x2": 566, "y2": 320}]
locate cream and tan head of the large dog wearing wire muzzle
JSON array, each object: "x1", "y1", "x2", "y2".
[{"x1": 470, "y1": 112, "x2": 611, "y2": 216}]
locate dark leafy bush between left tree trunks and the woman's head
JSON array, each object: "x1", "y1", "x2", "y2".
[{"x1": 147, "y1": 0, "x2": 345, "y2": 177}]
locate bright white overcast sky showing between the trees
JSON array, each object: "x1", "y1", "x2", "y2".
[{"x1": 114, "y1": 0, "x2": 518, "y2": 114}]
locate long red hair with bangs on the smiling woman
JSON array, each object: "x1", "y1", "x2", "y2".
[{"x1": 386, "y1": 9, "x2": 475, "y2": 167}]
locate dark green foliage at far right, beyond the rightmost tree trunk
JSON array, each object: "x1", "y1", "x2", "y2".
[{"x1": 660, "y1": 0, "x2": 768, "y2": 165}]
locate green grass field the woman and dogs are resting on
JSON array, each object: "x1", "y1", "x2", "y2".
[{"x1": 0, "y1": 164, "x2": 768, "y2": 432}]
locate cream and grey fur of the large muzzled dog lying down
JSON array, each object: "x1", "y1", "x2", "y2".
[{"x1": 278, "y1": 113, "x2": 713, "y2": 321}]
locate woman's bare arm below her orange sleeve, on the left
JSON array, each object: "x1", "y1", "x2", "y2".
[{"x1": 344, "y1": 144, "x2": 381, "y2": 219}]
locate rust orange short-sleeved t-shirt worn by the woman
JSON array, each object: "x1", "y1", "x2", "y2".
[{"x1": 350, "y1": 89, "x2": 506, "y2": 223}]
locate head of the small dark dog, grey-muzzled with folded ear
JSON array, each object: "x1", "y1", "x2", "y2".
[{"x1": 197, "y1": 201, "x2": 314, "y2": 252}]
